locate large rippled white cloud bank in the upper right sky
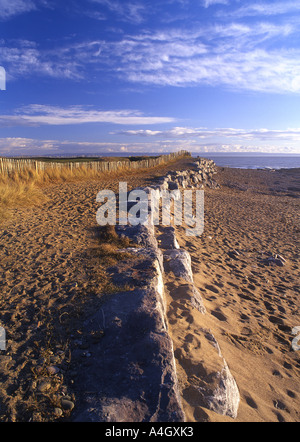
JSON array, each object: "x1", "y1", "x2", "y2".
[{"x1": 84, "y1": 23, "x2": 300, "y2": 93}]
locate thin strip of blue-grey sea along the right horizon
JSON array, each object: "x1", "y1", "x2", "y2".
[{"x1": 193, "y1": 153, "x2": 300, "y2": 169}]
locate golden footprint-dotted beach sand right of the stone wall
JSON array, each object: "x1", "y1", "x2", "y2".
[{"x1": 167, "y1": 169, "x2": 300, "y2": 422}]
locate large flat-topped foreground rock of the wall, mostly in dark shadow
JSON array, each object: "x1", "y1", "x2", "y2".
[{"x1": 72, "y1": 241, "x2": 184, "y2": 422}]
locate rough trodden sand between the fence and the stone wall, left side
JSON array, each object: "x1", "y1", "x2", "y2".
[{"x1": 0, "y1": 158, "x2": 190, "y2": 422}]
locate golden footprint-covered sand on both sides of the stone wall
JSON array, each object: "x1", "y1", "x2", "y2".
[{"x1": 0, "y1": 163, "x2": 300, "y2": 422}]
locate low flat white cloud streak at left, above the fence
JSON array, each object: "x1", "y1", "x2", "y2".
[{"x1": 0, "y1": 104, "x2": 174, "y2": 127}]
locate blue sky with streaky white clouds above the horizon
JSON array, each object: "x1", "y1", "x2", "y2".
[{"x1": 0, "y1": 0, "x2": 300, "y2": 156}]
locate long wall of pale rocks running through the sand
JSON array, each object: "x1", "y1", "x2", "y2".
[{"x1": 73, "y1": 160, "x2": 240, "y2": 422}]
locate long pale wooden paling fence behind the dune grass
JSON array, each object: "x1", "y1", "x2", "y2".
[{"x1": 0, "y1": 150, "x2": 191, "y2": 175}]
